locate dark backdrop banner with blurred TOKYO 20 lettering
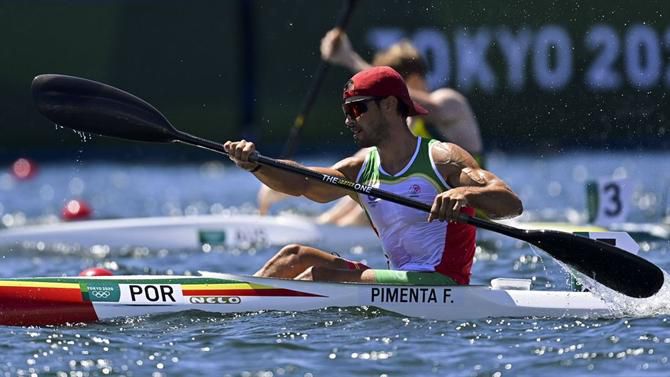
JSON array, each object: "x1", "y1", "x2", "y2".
[{"x1": 0, "y1": 0, "x2": 670, "y2": 156}]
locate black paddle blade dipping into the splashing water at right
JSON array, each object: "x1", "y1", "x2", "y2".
[{"x1": 519, "y1": 230, "x2": 665, "y2": 298}]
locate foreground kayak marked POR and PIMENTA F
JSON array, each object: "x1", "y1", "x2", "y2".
[{"x1": 0, "y1": 272, "x2": 612, "y2": 326}]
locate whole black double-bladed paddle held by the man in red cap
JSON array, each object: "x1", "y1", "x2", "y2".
[{"x1": 32, "y1": 75, "x2": 664, "y2": 297}]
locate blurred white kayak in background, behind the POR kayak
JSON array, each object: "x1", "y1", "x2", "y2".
[{"x1": 0, "y1": 214, "x2": 379, "y2": 249}]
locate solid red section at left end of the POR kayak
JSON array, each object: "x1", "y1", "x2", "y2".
[{"x1": 0, "y1": 287, "x2": 98, "y2": 326}]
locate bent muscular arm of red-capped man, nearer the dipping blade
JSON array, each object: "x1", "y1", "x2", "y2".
[{"x1": 428, "y1": 143, "x2": 523, "y2": 221}]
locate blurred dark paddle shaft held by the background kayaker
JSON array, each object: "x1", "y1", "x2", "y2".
[{"x1": 282, "y1": 0, "x2": 358, "y2": 158}]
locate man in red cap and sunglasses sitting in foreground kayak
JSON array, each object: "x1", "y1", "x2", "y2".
[{"x1": 224, "y1": 66, "x2": 522, "y2": 284}]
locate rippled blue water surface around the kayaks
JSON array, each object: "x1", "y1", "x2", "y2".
[{"x1": 0, "y1": 153, "x2": 670, "y2": 376}]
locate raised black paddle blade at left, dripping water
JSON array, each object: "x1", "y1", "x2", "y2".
[{"x1": 32, "y1": 74, "x2": 177, "y2": 143}]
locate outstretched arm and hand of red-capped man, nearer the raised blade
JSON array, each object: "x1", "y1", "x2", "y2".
[{"x1": 223, "y1": 140, "x2": 363, "y2": 203}]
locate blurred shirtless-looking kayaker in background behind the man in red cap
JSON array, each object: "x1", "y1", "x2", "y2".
[{"x1": 258, "y1": 28, "x2": 485, "y2": 226}]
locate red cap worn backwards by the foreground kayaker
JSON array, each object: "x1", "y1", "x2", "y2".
[{"x1": 342, "y1": 66, "x2": 428, "y2": 115}]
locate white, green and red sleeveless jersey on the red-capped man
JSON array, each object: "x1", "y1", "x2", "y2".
[{"x1": 356, "y1": 137, "x2": 475, "y2": 284}]
